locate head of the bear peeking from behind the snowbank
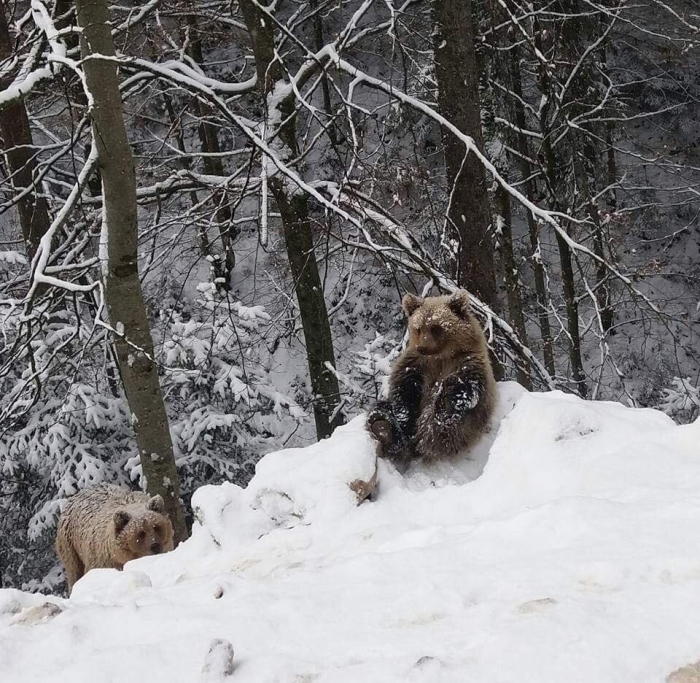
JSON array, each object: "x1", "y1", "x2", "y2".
[{"x1": 114, "y1": 496, "x2": 173, "y2": 560}]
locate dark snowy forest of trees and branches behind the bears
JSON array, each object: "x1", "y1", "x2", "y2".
[{"x1": 0, "y1": 0, "x2": 700, "y2": 590}]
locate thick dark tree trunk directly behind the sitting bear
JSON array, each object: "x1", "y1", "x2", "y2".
[{"x1": 433, "y1": 0, "x2": 498, "y2": 309}]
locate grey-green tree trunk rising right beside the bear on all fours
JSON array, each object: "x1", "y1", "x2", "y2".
[{"x1": 76, "y1": 0, "x2": 187, "y2": 541}]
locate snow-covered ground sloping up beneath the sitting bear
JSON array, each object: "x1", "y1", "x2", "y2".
[{"x1": 0, "y1": 384, "x2": 700, "y2": 683}]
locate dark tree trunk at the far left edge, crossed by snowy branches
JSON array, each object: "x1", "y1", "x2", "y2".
[{"x1": 0, "y1": 2, "x2": 51, "y2": 259}]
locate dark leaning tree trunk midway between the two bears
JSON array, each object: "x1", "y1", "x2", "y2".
[{"x1": 239, "y1": 0, "x2": 343, "y2": 439}]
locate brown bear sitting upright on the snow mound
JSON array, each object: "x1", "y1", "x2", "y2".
[{"x1": 367, "y1": 291, "x2": 496, "y2": 465}]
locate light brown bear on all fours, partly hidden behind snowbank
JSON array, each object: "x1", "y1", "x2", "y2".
[{"x1": 56, "y1": 484, "x2": 173, "y2": 591}]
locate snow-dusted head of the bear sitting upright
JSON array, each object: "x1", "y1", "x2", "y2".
[{"x1": 401, "y1": 291, "x2": 486, "y2": 358}]
